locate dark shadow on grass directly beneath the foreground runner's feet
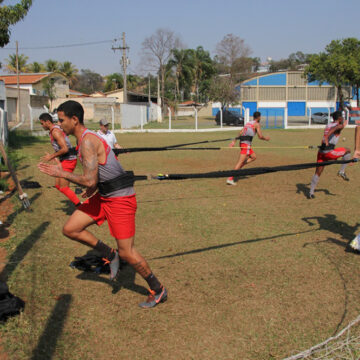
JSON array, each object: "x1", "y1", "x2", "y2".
[{"x1": 76, "y1": 250, "x2": 148, "y2": 295}]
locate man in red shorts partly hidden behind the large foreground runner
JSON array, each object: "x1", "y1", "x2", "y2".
[{"x1": 39, "y1": 113, "x2": 80, "y2": 206}]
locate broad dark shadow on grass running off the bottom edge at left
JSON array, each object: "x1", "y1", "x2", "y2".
[{"x1": 31, "y1": 294, "x2": 72, "y2": 360}]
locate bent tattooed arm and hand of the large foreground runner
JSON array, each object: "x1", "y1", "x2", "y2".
[{"x1": 38, "y1": 137, "x2": 98, "y2": 190}]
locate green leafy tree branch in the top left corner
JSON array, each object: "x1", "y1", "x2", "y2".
[{"x1": 0, "y1": 0, "x2": 32, "y2": 47}]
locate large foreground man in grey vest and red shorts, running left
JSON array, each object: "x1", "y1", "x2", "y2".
[{"x1": 38, "y1": 100, "x2": 167, "y2": 308}]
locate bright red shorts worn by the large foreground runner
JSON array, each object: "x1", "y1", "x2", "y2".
[{"x1": 78, "y1": 193, "x2": 137, "y2": 240}]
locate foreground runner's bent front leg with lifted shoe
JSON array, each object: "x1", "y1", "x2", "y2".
[{"x1": 63, "y1": 210, "x2": 120, "y2": 280}]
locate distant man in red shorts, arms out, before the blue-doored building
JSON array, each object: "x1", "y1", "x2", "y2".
[{"x1": 226, "y1": 111, "x2": 270, "y2": 185}]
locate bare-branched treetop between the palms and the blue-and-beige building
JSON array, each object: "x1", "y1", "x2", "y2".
[{"x1": 216, "y1": 34, "x2": 251, "y2": 78}]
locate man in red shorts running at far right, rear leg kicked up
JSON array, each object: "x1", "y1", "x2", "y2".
[{"x1": 308, "y1": 111, "x2": 351, "y2": 199}]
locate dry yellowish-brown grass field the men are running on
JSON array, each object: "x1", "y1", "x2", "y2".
[{"x1": 0, "y1": 129, "x2": 360, "y2": 360}]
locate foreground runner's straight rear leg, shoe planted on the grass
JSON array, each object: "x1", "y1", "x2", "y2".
[{"x1": 116, "y1": 237, "x2": 167, "y2": 308}]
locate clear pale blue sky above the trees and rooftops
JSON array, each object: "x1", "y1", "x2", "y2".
[{"x1": 0, "y1": 0, "x2": 360, "y2": 75}]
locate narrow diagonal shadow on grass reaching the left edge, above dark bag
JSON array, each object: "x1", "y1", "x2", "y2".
[{"x1": 0, "y1": 221, "x2": 50, "y2": 282}]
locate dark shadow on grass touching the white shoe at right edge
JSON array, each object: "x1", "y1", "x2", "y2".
[{"x1": 302, "y1": 214, "x2": 360, "y2": 242}]
